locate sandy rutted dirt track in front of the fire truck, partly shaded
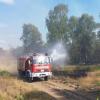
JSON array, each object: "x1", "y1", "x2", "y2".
[{"x1": 27, "y1": 80, "x2": 96, "y2": 100}]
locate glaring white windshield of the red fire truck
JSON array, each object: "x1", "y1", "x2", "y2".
[{"x1": 33, "y1": 56, "x2": 50, "y2": 64}]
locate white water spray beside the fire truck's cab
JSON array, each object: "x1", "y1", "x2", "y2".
[{"x1": 50, "y1": 42, "x2": 69, "y2": 65}]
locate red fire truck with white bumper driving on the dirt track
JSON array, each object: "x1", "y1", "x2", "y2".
[{"x1": 17, "y1": 53, "x2": 52, "y2": 81}]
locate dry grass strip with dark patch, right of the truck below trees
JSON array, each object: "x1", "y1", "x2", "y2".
[{"x1": 53, "y1": 65, "x2": 100, "y2": 89}]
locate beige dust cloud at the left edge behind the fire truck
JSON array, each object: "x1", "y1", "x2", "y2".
[{"x1": 0, "y1": 51, "x2": 17, "y2": 74}]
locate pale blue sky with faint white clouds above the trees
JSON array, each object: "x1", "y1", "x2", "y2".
[{"x1": 0, "y1": 0, "x2": 100, "y2": 49}]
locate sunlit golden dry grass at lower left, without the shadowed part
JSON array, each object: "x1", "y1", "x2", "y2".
[{"x1": 0, "y1": 77, "x2": 33, "y2": 100}]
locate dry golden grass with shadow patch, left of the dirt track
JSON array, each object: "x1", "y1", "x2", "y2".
[{"x1": 0, "y1": 77, "x2": 55, "y2": 100}]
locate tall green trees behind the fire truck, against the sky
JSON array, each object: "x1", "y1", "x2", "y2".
[{"x1": 21, "y1": 4, "x2": 100, "y2": 64}]
